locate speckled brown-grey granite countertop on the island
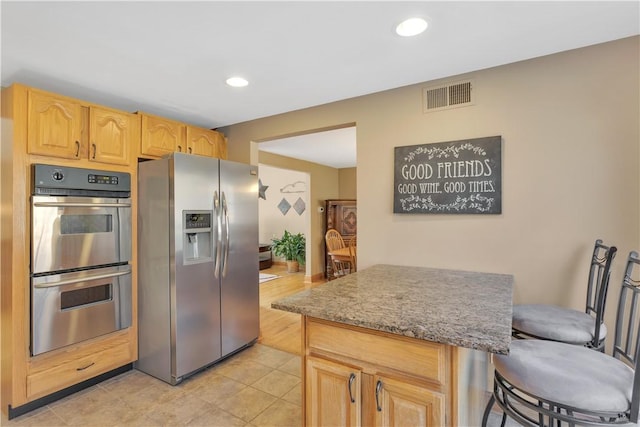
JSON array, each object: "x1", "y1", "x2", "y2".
[{"x1": 271, "y1": 265, "x2": 513, "y2": 354}]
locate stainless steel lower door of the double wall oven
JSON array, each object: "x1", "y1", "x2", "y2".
[{"x1": 31, "y1": 264, "x2": 131, "y2": 356}]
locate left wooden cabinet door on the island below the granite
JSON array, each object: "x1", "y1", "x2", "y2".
[{"x1": 305, "y1": 357, "x2": 362, "y2": 426}]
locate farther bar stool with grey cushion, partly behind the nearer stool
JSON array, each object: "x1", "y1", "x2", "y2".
[{"x1": 512, "y1": 240, "x2": 617, "y2": 351}]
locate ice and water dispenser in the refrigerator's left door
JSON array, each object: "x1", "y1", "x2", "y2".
[{"x1": 183, "y1": 211, "x2": 213, "y2": 264}]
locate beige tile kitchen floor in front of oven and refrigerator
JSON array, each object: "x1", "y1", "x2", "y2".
[{"x1": 1, "y1": 344, "x2": 302, "y2": 427}]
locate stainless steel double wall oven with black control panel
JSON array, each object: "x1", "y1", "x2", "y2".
[{"x1": 30, "y1": 164, "x2": 132, "y2": 356}]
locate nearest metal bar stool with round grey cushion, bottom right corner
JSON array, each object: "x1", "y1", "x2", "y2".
[{"x1": 482, "y1": 251, "x2": 640, "y2": 426}]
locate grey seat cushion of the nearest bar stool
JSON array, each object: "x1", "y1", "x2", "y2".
[{"x1": 493, "y1": 340, "x2": 634, "y2": 413}]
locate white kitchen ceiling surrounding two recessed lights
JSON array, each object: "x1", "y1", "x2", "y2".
[{"x1": 0, "y1": 0, "x2": 640, "y2": 169}]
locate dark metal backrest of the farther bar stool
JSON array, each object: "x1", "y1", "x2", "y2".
[{"x1": 585, "y1": 239, "x2": 618, "y2": 349}]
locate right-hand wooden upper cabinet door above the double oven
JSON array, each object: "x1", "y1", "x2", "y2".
[{"x1": 89, "y1": 107, "x2": 139, "y2": 165}]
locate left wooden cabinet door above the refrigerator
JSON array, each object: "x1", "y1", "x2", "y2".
[{"x1": 140, "y1": 114, "x2": 187, "y2": 157}]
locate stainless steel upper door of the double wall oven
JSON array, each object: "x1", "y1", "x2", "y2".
[{"x1": 31, "y1": 196, "x2": 131, "y2": 274}]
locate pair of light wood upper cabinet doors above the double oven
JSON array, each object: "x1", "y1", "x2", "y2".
[{"x1": 27, "y1": 89, "x2": 140, "y2": 165}]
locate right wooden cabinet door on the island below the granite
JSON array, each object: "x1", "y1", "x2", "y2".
[{"x1": 375, "y1": 376, "x2": 445, "y2": 427}]
